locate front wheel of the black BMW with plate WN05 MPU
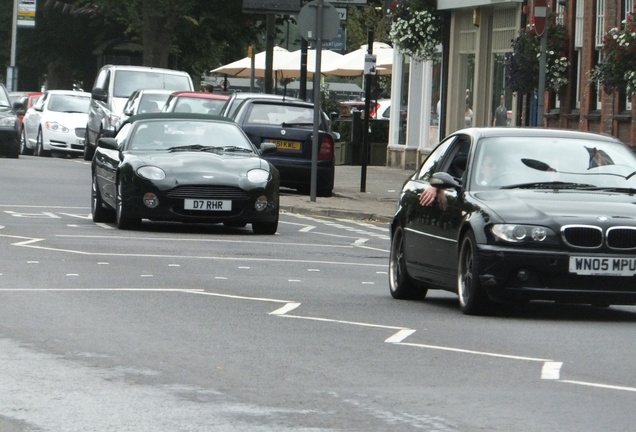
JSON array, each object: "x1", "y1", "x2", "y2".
[{"x1": 457, "y1": 231, "x2": 491, "y2": 315}]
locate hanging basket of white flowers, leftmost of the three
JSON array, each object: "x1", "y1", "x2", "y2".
[{"x1": 388, "y1": 0, "x2": 442, "y2": 62}]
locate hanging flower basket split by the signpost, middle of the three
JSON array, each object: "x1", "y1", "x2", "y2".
[{"x1": 505, "y1": 15, "x2": 570, "y2": 94}]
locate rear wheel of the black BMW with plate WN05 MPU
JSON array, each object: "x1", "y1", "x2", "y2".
[{"x1": 389, "y1": 226, "x2": 428, "y2": 300}]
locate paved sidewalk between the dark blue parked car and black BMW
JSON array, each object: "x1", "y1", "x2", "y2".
[{"x1": 280, "y1": 165, "x2": 413, "y2": 222}]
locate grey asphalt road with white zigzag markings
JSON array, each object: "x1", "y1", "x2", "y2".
[{"x1": 0, "y1": 157, "x2": 636, "y2": 432}]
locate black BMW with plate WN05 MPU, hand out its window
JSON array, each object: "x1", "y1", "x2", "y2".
[{"x1": 389, "y1": 128, "x2": 636, "y2": 314}]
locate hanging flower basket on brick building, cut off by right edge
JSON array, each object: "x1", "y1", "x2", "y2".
[{"x1": 590, "y1": 13, "x2": 636, "y2": 94}]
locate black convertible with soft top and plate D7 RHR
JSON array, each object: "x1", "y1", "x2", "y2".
[{"x1": 91, "y1": 113, "x2": 280, "y2": 234}]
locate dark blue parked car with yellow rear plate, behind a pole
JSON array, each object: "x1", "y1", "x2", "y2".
[{"x1": 231, "y1": 98, "x2": 336, "y2": 197}]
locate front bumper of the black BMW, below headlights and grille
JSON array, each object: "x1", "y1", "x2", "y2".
[{"x1": 477, "y1": 247, "x2": 636, "y2": 305}]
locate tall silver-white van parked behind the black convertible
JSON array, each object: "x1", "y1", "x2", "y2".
[{"x1": 84, "y1": 65, "x2": 194, "y2": 160}]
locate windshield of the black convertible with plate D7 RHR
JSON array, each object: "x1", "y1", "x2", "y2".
[{"x1": 128, "y1": 119, "x2": 254, "y2": 154}]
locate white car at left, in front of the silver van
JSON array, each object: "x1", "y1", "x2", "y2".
[{"x1": 20, "y1": 90, "x2": 91, "y2": 156}]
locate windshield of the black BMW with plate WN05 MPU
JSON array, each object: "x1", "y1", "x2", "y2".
[{"x1": 471, "y1": 136, "x2": 636, "y2": 189}]
